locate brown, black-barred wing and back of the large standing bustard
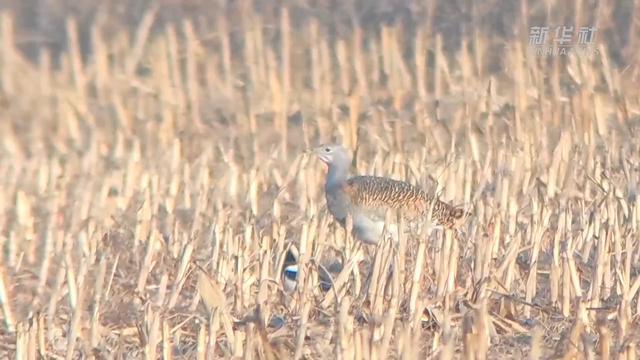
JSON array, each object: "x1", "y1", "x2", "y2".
[{"x1": 344, "y1": 176, "x2": 465, "y2": 227}]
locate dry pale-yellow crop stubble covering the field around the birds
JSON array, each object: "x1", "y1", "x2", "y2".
[{"x1": 0, "y1": 0, "x2": 640, "y2": 359}]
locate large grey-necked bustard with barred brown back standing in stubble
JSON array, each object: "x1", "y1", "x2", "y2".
[{"x1": 307, "y1": 144, "x2": 470, "y2": 244}]
